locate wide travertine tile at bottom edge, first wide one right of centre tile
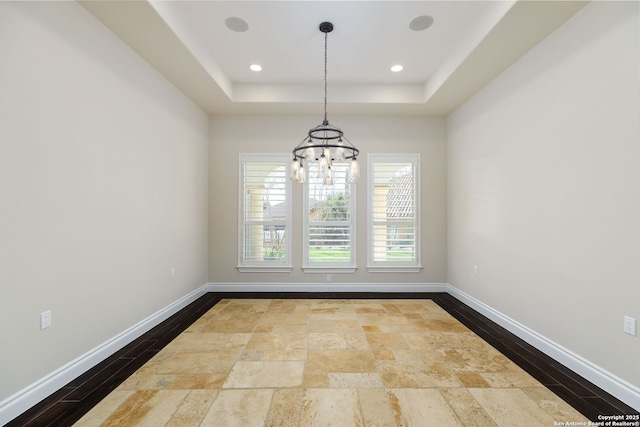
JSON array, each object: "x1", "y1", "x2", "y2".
[{"x1": 389, "y1": 388, "x2": 463, "y2": 427}]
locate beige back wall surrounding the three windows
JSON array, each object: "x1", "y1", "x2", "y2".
[{"x1": 209, "y1": 115, "x2": 446, "y2": 285}]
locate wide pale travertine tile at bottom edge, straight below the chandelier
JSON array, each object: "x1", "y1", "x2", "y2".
[{"x1": 300, "y1": 388, "x2": 364, "y2": 427}]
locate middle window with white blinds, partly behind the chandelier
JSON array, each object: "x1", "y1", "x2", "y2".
[{"x1": 302, "y1": 162, "x2": 356, "y2": 273}]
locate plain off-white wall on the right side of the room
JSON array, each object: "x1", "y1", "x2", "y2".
[{"x1": 447, "y1": 2, "x2": 640, "y2": 387}]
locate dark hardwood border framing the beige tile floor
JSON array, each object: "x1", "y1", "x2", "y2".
[{"x1": 6, "y1": 292, "x2": 638, "y2": 427}]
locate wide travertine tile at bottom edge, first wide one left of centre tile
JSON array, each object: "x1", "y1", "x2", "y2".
[{"x1": 202, "y1": 389, "x2": 273, "y2": 427}]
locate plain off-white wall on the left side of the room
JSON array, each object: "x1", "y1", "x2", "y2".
[{"x1": 0, "y1": 2, "x2": 208, "y2": 401}]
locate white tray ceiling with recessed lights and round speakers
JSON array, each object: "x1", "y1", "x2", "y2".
[{"x1": 80, "y1": 0, "x2": 586, "y2": 115}]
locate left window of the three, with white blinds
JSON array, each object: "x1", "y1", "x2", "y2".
[{"x1": 238, "y1": 154, "x2": 291, "y2": 272}]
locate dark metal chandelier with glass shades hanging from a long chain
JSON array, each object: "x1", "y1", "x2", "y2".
[{"x1": 289, "y1": 22, "x2": 360, "y2": 185}]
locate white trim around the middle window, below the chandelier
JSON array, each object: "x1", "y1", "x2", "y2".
[{"x1": 302, "y1": 164, "x2": 358, "y2": 274}]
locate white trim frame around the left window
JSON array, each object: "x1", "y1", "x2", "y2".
[{"x1": 236, "y1": 153, "x2": 293, "y2": 273}]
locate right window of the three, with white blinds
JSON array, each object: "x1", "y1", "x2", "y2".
[{"x1": 367, "y1": 154, "x2": 422, "y2": 272}]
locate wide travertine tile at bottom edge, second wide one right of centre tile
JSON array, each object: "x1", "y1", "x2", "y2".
[{"x1": 468, "y1": 388, "x2": 554, "y2": 427}]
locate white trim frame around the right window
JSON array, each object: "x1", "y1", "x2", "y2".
[{"x1": 367, "y1": 153, "x2": 422, "y2": 273}]
